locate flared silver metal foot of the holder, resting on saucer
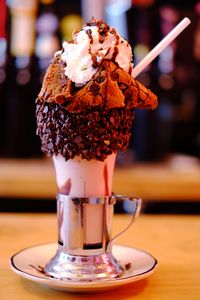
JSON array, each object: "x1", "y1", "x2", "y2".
[{"x1": 44, "y1": 250, "x2": 123, "y2": 281}]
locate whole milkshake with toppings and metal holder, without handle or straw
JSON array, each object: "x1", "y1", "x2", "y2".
[{"x1": 36, "y1": 18, "x2": 158, "y2": 280}]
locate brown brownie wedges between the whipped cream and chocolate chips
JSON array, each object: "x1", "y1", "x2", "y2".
[{"x1": 37, "y1": 57, "x2": 158, "y2": 112}]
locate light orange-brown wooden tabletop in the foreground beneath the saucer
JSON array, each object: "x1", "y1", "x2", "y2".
[{"x1": 0, "y1": 213, "x2": 200, "y2": 300}]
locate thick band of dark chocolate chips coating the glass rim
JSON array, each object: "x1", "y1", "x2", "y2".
[{"x1": 36, "y1": 103, "x2": 134, "y2": 161}]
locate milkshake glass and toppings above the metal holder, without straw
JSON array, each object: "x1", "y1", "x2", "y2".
[{"x1": 36, "y1": 18, "x2": 157, "y2": 196}]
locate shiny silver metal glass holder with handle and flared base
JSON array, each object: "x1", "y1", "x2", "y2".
[{"x1": 44, "y1": 194, "x2": 141, "y2": 281}]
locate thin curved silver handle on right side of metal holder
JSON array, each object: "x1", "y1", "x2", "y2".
[{"x1": 107, "y1": 195, "x2": 142, "y2": 252}]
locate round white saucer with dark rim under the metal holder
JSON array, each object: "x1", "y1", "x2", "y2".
[{"x1": 10, "y1": 244, "x2": 157, "y2": 293}]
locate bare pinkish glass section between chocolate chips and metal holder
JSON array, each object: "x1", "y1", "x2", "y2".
[{"x1": 53, "y1": 153, "x2": 116, "y2": 197}]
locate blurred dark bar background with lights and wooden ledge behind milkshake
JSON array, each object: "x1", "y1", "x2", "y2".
[{"x1": 0, "y1": 0, "x2": 200, "y2": 212}]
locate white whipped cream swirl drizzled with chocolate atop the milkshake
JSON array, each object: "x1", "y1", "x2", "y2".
[{"x1": 61, "y1": 26, "x2": 133, "y2": 87}]
